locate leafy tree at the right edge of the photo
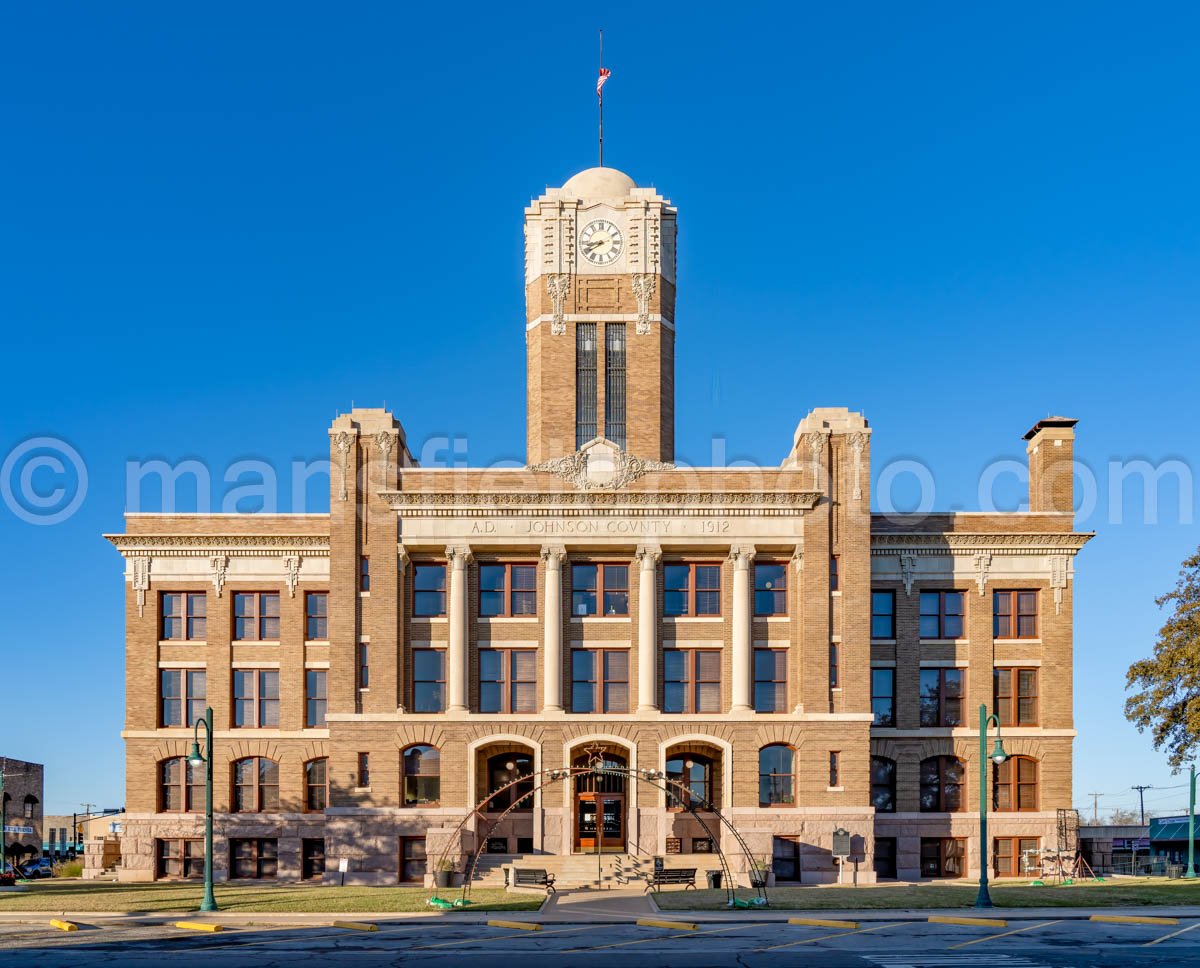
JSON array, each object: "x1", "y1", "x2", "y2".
[{"x1": 1126, "y1": 551, "x2": 1200, "y2": 772}]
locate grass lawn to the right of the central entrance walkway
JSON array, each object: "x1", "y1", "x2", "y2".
[{"x1": 654, "y1": 878, "x2": 1200, "y2": 910}]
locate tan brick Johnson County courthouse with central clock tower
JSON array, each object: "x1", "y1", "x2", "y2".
[{"x1": 109, "y1": 168, "x2": 1088, "y2": 884}]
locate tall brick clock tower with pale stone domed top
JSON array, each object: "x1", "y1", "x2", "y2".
[{"x1": 524, "y1": 168, "x2": 676, "y2": 465}]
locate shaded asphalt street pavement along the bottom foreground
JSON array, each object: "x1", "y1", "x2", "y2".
[{"x1": 0, "y1": 910, "x2": 1200, "y2": 968}]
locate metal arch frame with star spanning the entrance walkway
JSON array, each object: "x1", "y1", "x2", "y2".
[{"x1": 433, "y1": 746, "x2": 769, "y2": 907}]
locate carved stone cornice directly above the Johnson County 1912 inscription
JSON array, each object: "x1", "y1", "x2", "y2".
[{"x1": 379, "y1": 491, "x2": 822, "y2": 517}]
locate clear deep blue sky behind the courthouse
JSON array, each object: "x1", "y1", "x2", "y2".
[{"x1": 0, "y1": 2, "x2": 1200, "y2": 812}]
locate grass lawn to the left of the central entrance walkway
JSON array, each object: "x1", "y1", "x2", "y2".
[{"x1": 0, "y1": 880, "x2": 544, "y2": 914}]
